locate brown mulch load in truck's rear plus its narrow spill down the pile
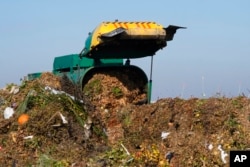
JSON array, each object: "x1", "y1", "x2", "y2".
[{"x1": 83, "y1": 71, "x2": 146, "y2": 144}]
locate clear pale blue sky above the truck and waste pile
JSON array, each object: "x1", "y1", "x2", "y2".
[{"x1": 0, "y1": 0, "x2": 250, "y2": 100}]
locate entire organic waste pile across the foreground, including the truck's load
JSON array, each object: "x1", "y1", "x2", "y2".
[{"x1": 0, "y1": 73, "x2": 250, "y2": 167}]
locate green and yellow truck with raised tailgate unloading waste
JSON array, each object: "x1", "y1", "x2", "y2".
[{"x1": 28, "y1": 20, "x2": 185, "y2": 104}]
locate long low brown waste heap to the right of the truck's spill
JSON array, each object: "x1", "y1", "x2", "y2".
[{"x1": 119, "y1": 96, "x2": 250, "y2": 167}]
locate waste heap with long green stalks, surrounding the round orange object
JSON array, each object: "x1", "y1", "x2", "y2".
[{"x1": 0, "y1": 78, "x2": 102, "y2": 166}]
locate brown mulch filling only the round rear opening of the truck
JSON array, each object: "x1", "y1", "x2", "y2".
[{"x1": 83, "y1": 73, "x2": 146, "y2": 109}]
